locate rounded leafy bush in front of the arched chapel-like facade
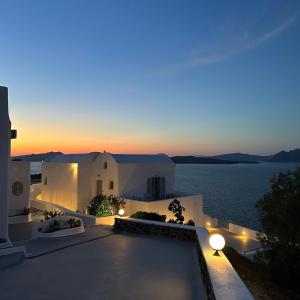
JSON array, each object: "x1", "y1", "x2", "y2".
[{"x1": 88, "y1": 194, "x2": 126, "y2": 217}]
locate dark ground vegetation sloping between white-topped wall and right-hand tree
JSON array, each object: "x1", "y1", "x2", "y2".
[{"x1": 223, "y1": 246, "x2": 300, "y2": 300}]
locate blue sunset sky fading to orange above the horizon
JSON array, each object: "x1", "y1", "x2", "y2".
[{"x1": 0, "y1": 0, "x2": 300, "y2": 155}]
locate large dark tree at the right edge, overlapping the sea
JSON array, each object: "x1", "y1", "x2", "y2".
[{"x1": 256, "y1": 168, "x2": 300, "y2": 289}]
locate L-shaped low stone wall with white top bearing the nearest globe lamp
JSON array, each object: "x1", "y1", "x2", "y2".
[{"x1": 114, "y1": 218, "x2": 254, "y2": 300}]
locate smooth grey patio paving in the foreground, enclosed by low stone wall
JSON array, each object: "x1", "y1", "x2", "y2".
[{"x1": 0, "y1": 233, "x2": 206, "y2": 300}]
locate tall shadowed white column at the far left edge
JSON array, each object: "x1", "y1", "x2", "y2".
[{"x1": 0, "y1": 86, "x2": 11, "y2": 241}]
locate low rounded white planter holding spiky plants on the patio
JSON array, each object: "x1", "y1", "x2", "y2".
[{"x1": 36, "y1": 216, "x2": 85, "y2": 238}]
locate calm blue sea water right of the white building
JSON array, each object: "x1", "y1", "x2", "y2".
[{"x1": 176, "y1": 163, "x2": 300, "y2": 229}]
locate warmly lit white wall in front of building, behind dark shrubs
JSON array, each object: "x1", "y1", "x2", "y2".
[{"x1": 125, "y1": 195, "x2": 205, "y2": 226}]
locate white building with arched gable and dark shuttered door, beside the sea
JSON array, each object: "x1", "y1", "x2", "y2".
[{"x1": 41, "y1": 152, "x2": 175, "y2": 211}]
